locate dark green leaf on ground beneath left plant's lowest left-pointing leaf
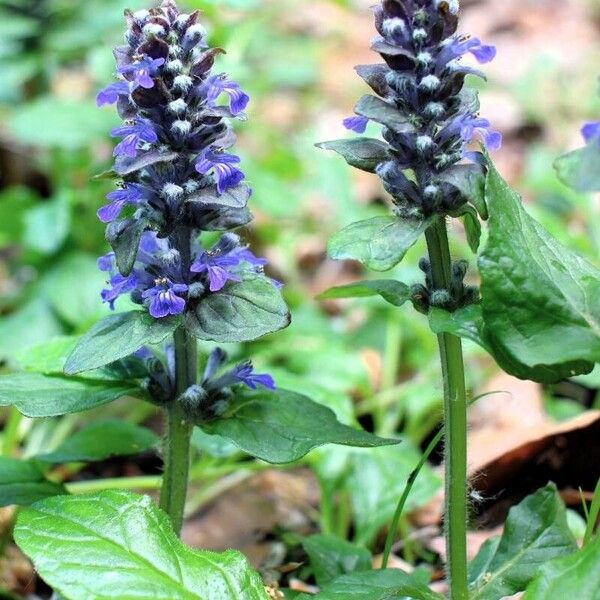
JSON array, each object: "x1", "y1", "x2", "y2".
[{"x1": 35, "y1": 420, "x2": 159, "y2": 464}]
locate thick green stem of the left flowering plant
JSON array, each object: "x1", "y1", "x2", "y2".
[{"x1": 160, "y1": 327, "x2": 197, "y2": 533}]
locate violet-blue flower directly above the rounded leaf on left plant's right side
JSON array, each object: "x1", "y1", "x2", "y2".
[{"x1": 190, "y1": 234, "x2": 267, "y2": 292}]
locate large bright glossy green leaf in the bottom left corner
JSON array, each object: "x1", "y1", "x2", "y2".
[{"x1": 14, "y1": 490, "x2": 267, "y2": 600}]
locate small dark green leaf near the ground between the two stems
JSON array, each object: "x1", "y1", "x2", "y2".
[{"x1": 302, "y1": 535, "x2": 372, "y2": 587}]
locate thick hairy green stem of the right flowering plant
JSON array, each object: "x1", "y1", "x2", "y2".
[{"x1": 425, "y1": 217, "x2": 468, "y2": 600}]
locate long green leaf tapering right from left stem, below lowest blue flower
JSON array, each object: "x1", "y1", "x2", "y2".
[{"x1": 199, "y1": 390, "x2": 398, "y2": 464}]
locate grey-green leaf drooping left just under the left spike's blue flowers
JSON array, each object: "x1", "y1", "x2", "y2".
[{"x1": 65, "y1": 310, "x2": 179, "y2": 375}]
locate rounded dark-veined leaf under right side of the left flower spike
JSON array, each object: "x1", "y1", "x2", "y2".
[{"x1": 186, "y1": 277, "x2": 290, "y2": 342}]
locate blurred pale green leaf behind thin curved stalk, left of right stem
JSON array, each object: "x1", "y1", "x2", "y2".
[{"x1": 346, "y1": 441, "x2": 441, "y2": 544}]
